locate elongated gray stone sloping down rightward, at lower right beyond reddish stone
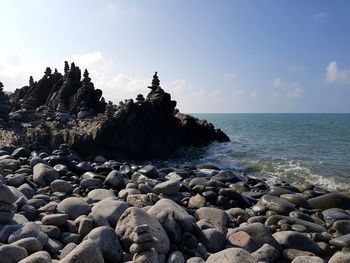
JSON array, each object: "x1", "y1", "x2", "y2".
[{"x1": 272, "y1": 231, "x2": 320, "y2": 254}]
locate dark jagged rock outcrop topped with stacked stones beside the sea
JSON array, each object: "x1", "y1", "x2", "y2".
[{"x1": 0, "y1": 65, "x2": 229, "y2": 159}]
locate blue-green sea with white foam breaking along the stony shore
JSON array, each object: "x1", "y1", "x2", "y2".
[{"x1": 168, "y1": 114, "x2": 350, "y2": 190}]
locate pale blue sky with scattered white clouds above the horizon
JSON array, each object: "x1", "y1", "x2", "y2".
[{"x1": 0, "y1": 0, "x2": 350, "y2": 113}]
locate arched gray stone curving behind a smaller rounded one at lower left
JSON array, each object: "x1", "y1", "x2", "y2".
[{"x1": 8, "y1": 222, "x2": 49, "y2": 246}]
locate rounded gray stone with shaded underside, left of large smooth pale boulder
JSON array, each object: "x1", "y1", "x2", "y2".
[{"x1": 57, "y1": 197, "x2": 90, "y2": 220}]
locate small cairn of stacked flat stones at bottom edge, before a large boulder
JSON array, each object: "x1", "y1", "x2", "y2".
[{"x1": 129, "y1": 224, "x2": 158, "y2": 263}]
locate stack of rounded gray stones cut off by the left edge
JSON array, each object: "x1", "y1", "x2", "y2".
[{"x1": 0, "y1": 183, "x2": 16, "y2": 225}]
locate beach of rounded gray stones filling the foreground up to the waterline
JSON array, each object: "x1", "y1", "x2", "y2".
[{"x1": 0, "y1": 144, "x2": 350, "y2": 263}]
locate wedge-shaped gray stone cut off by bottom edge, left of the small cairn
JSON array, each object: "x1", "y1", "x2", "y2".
[{"x1": 60, "y1": 239, "x2": 104, "y2": 263}]
